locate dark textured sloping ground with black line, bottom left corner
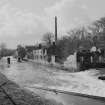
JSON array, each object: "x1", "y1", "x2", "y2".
[{"x1": 0, "y1": 73, "x2": 60, "y2": 105}]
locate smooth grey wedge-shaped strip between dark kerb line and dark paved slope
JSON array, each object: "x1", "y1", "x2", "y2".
[{"x1": 26, "y1": 88, "x2": 105, "y2": 105}]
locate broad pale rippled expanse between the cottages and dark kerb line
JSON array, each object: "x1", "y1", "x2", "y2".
[{"x1": 0, "y1": 62, "x2": 105, "y2": 97}]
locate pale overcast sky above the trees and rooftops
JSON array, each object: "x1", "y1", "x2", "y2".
[{"x1": 0, "y1": 0, "x2": 105, "y2": 48}]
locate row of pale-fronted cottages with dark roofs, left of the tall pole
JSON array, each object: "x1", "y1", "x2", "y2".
[{"x1": 26, "y1": 44, "x2": 55, "y2": 64}]
